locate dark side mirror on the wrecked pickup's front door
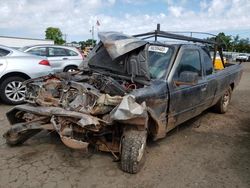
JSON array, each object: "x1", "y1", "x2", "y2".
[{"x1": 174, "y1": 71, "x2": 199, "y2": 86}]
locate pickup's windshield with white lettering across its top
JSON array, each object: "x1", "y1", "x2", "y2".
[{"x1": 148, "y1": 45, "x2": 173, "y2": 79}]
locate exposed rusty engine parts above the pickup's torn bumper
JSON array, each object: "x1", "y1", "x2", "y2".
[{"x1": 26, "y1": 73, "x2": 142, "y2": 110}]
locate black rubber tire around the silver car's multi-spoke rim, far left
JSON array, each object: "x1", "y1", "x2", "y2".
[{"x1": 0, "y1": 76, "x2": 25, "y2": 105}]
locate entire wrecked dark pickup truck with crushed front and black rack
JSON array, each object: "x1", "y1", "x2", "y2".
[{"x1": 4, "y1": 27, "x2": 242, "y2": 173}]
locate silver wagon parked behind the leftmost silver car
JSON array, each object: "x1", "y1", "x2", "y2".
[{"x1": 20, "y1": 45, "x2": 84, "y2": 72}]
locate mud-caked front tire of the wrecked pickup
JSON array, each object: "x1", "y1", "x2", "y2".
[{"x1": 121, "y1": 130, "x2": 147, "y2": 174}]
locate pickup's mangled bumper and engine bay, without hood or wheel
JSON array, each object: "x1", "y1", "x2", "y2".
[{"x1": 4, "y1": 72, "x2": 147, "y2": 154}]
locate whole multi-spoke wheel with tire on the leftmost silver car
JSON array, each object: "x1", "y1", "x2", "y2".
[{"x1": 0, "y1": 77, "x2": 26, "y2": 105}]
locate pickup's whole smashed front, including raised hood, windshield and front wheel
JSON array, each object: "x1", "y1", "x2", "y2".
[{"x1": 4, "y1": 32, "x2": 173, "y2": 173}]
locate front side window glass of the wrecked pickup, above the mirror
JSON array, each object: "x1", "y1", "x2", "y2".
[{"x1": 175, "y1": 50, "x2": 202, "y2": 77}]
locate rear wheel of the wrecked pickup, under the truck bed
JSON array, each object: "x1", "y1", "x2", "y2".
[{"x1": 214, "y1": 87, "x2": 232, "y2": 114}]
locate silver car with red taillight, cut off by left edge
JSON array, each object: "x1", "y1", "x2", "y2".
[{"x1": 0, "y1": 45, "x2": 53, "y2": 104}]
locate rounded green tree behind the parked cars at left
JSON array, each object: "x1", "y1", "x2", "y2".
[{"x1": 45, "y1": 27, "x2": 65, "y2": 44}]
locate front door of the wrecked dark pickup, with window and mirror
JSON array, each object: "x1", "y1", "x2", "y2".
[{"x1": 168, "y1": 45, "x2": 207, "y2": 127}]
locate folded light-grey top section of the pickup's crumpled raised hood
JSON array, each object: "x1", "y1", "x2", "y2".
[{"x1": 98, "y1": 32, "x2": 147, "y2": 60}]
